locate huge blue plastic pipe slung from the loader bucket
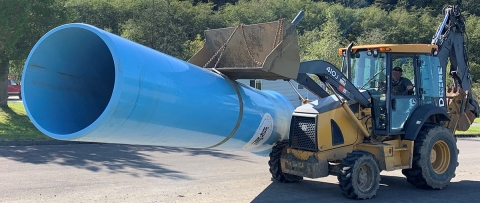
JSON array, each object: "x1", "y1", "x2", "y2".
[{"x1": 22, "y1": 24, "x2": 293, "y2": 154}]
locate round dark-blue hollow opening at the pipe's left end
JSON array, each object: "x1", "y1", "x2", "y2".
[{"x1": 22, "y1": 27, "x2": 115, "y2": 136}]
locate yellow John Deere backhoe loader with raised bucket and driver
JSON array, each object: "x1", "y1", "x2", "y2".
[{"x1": 189, "y1": 6, "x2": 479, "y2": 199}]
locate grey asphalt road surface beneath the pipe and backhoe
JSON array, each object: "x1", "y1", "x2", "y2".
[{"x1": 0, "y1": 138, "x2": 480, "y2": 203}]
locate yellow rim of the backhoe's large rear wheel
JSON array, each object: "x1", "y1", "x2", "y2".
[{"x1": 430, "y1": 140, "x2": 450, "y2": 174}]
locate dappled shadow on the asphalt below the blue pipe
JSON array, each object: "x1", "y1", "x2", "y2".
[{"x1": 0, "y1": 144, "x2": 248, "y2": 179}]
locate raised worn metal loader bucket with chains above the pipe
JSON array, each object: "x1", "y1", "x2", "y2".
[{"x1": 188, "y1": 19, "x2": 300, "y2": 80}]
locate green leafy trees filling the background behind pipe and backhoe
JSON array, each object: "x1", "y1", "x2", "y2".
[{"x1": 0, "y1": 0, "x2": 480, "y2": 105}]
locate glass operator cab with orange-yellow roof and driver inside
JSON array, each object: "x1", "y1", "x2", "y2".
[{"x1": 339, "y1": 44, "x2": 446, "y2": 135}]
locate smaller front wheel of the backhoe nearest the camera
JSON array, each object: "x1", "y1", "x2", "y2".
[{"x1": 337, "y1": 150, "x2": 380, "y2": 199}]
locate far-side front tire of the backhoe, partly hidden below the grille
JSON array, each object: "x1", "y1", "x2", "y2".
[{"x1": 268, "y1": 140, "x2": 303, "y2": 183}]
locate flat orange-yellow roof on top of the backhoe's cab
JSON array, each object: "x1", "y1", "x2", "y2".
[{"x1": 338, "y1": 44, "x2": 438, "y2": 54}]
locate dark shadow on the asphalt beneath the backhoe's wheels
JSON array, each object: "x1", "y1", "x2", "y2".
[{"x1": 252, "y1": 175, "x2": 480, "y2": 203}]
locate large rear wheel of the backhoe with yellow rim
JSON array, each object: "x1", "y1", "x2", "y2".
[{"x1": 402, "y1": 126, "x2": 458, "y2": 189}]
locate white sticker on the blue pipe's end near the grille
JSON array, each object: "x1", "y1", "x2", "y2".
[{"x1": 243, "y1": 113, "x2": 273, "y2": 150}]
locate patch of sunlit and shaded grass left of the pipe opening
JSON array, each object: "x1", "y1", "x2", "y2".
[{"x1": 0, "y1": 102, "x2": 51, "y2": 141}]
